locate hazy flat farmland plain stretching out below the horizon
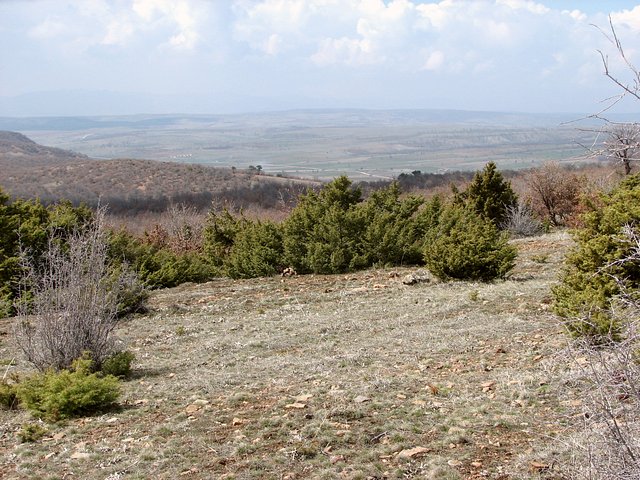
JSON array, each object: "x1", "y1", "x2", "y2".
[{"x1": 0, "y1": 110, "x2": 593, "y2": 180}]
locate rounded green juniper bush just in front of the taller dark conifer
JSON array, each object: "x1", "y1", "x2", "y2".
[{"x1": 424, "y1": 205, "x2": 516, "y2": 281}]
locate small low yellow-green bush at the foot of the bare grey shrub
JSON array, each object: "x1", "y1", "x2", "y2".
[{"x1": 17, "y1": 359, "x2": 120, "y2": 421}]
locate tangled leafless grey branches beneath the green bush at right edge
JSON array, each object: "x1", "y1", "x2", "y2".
[{"x1": 556, "y1": 225, "x2": 640, "y2": 480}]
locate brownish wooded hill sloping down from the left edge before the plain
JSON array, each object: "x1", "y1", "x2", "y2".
[{"x1": 0, "y1": 131, "x2": 317, "y2": 213}]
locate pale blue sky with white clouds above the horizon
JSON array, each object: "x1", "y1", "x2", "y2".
[{"x1": 0, "y1": 0, "x2": 640, "y2": 116}]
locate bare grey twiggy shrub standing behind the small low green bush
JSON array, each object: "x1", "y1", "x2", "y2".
[{"x1": 16, "y1": 210, "x2": 137, "y2": 371}]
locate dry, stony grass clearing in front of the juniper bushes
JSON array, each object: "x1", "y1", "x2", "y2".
[{"x1": 0, "y1": 234, "x2": 572, "y2": 480}]
